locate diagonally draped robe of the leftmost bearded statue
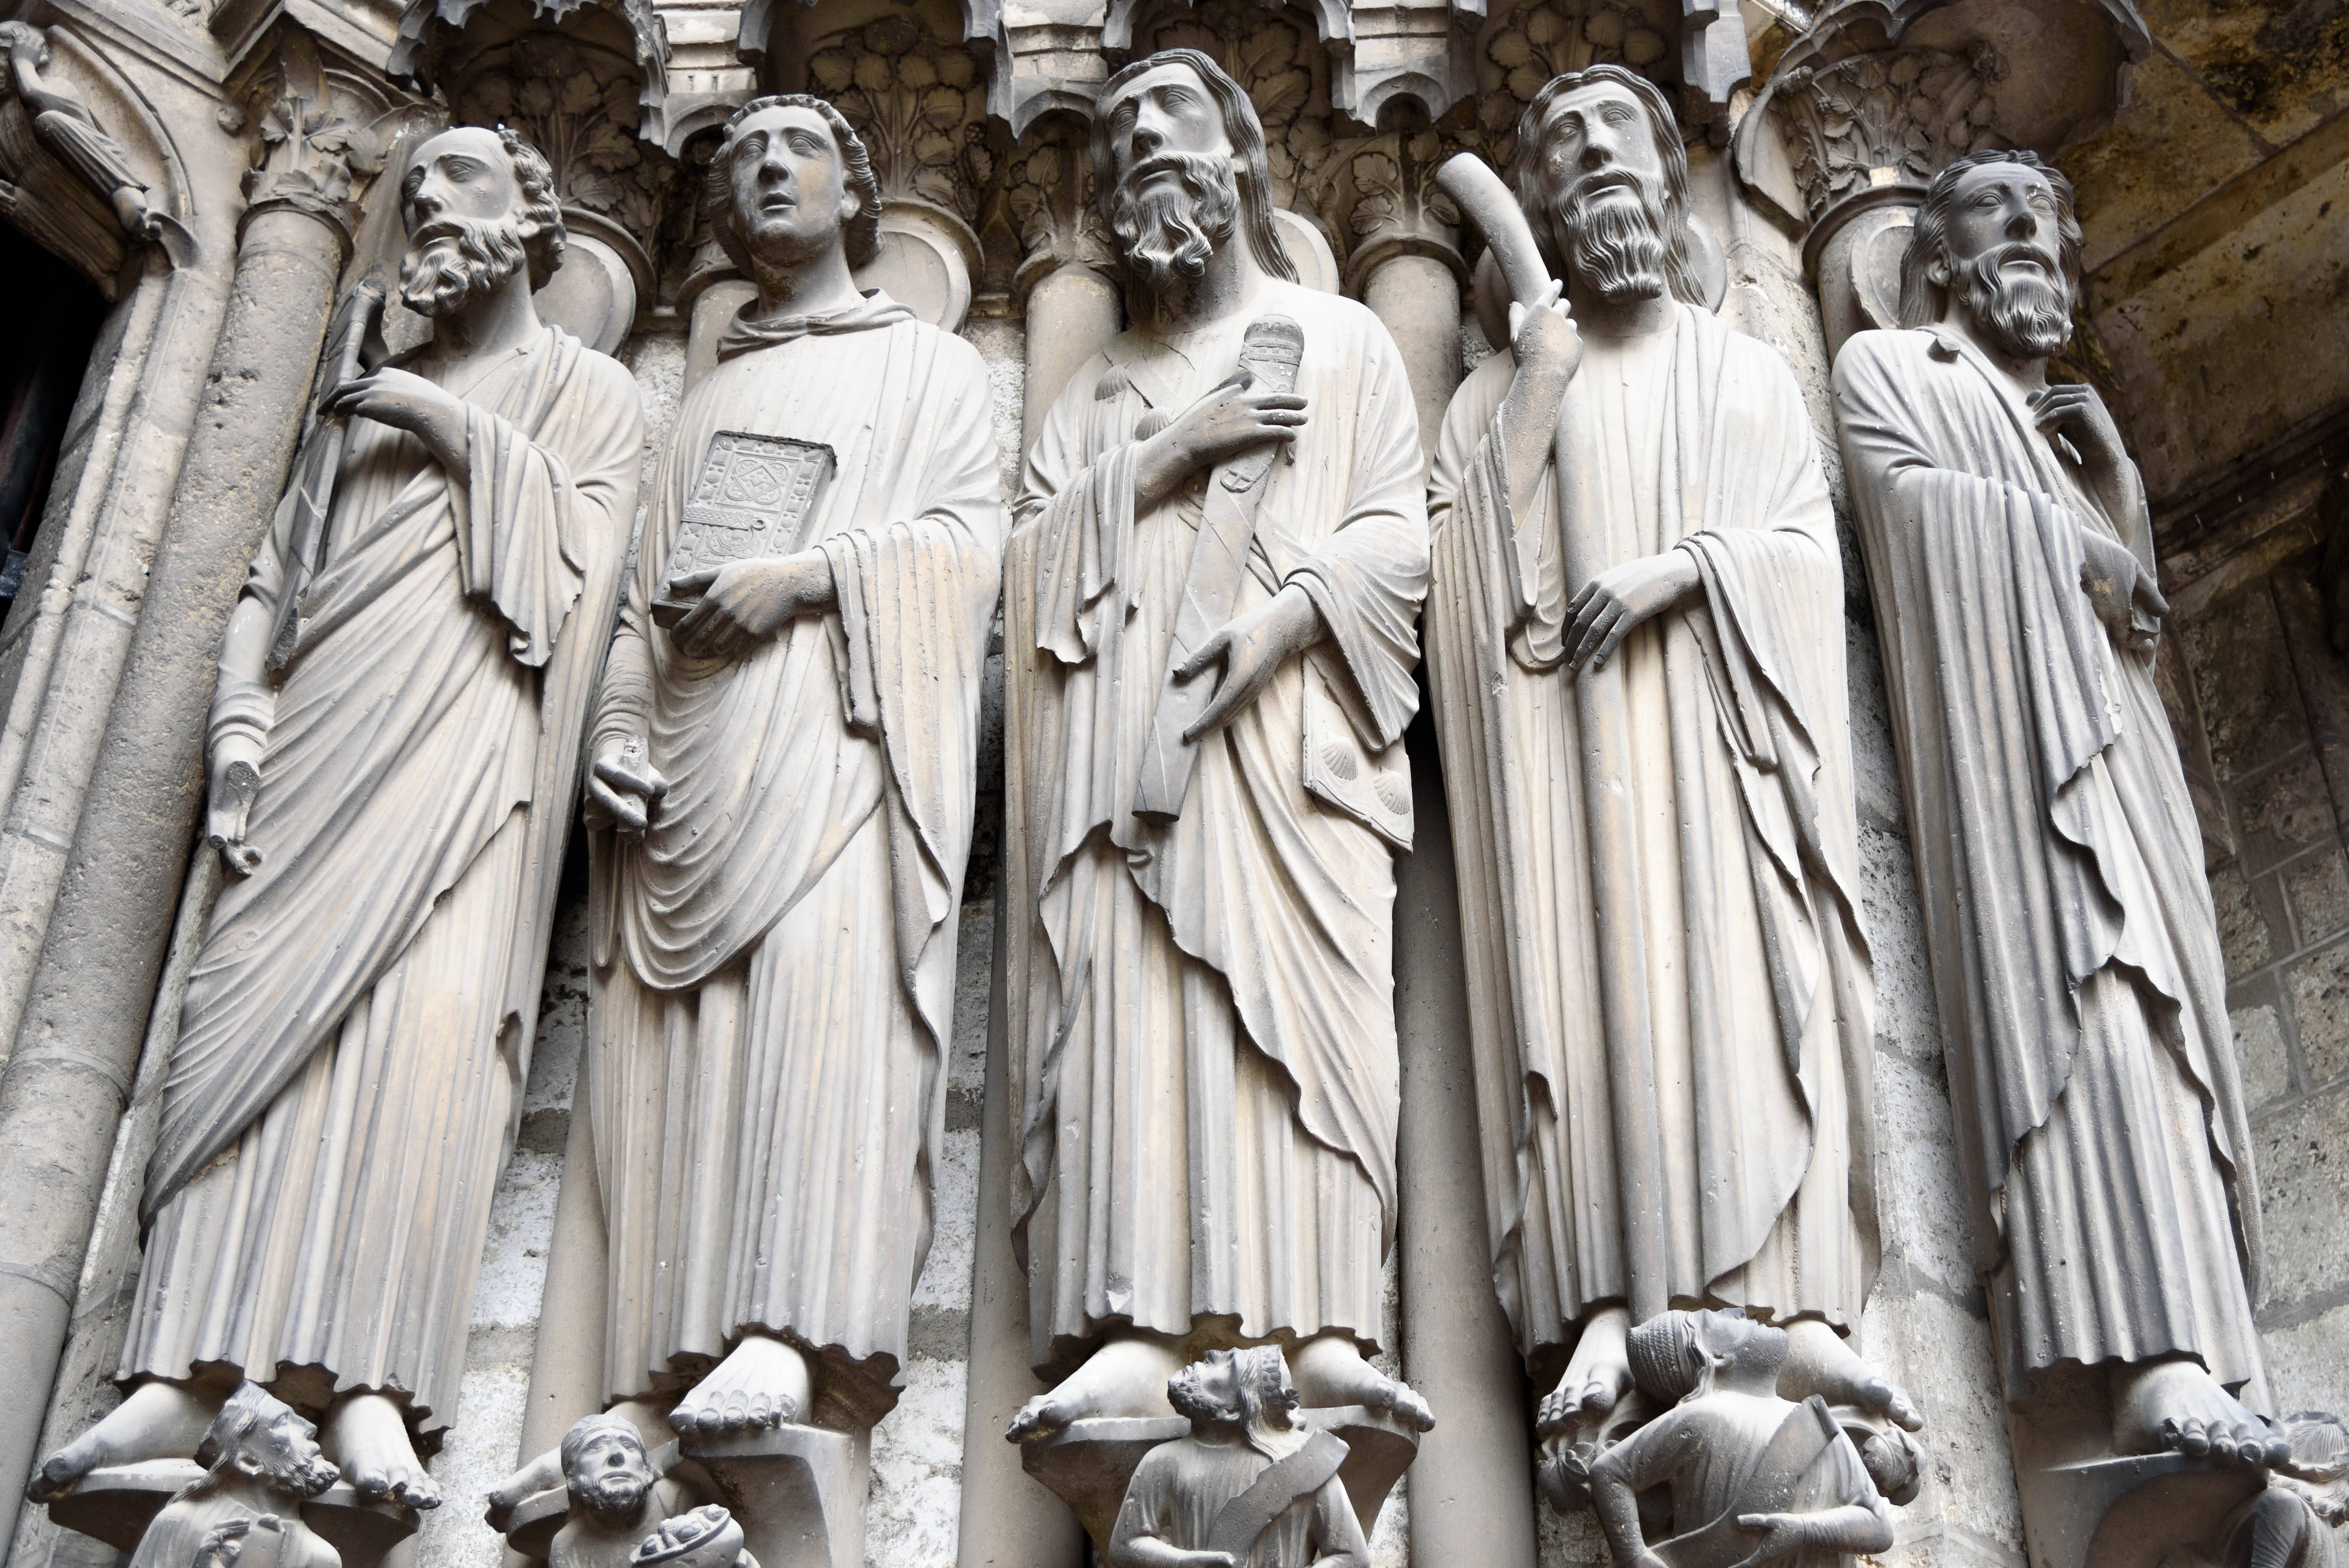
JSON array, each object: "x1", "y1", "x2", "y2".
[{"x1": 122, "y1": 326, "x2": 644, "y2": 1441}]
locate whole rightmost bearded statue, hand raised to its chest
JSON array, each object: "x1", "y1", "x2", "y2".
[{"x1": 1835, "y1": 152, "x2": 2290, "y2": 1474}]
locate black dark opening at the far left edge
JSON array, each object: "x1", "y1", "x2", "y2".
[{"x1": 0, "y1": 225, "x2": 105, "y2": 619}]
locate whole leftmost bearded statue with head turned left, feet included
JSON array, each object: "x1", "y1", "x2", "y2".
[{"x1": 33, "y1": 129, "x2": 644, "y2": 1507}]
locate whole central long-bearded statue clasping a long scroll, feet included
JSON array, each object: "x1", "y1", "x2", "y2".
[{"x1": 1003, "y1": 49, "x2": 1433, "y2": 1439}]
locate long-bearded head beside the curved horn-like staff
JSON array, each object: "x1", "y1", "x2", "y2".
[{"x1": 1513, "y1": 66, "x2": 1705, "y2": 303}]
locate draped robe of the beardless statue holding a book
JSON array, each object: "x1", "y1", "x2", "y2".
[{"x1": 587, "y1": 293, "x2": 1003, "y2": 1425}]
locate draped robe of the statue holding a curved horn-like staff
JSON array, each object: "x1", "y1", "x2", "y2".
[{"x1": 1428, "y1": 305, "x2": 1877, "y2": 1378}]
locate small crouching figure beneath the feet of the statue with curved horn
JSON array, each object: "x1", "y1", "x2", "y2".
[{"x1": 1590, "y1": 1310, "x2": 1893, "y2": 1568}]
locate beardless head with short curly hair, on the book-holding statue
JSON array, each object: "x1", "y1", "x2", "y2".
[{"x1": 702, "y1": 92, "x2": 881, "y2": 272}]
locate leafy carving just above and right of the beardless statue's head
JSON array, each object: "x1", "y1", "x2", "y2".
[{"x1": 808, "y1": 16, "x2": 996, "y2": 223}]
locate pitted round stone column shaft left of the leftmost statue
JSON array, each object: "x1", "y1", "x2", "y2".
[{"x1": 0, "y1": 204, "x2": 350, "y2": 1535}]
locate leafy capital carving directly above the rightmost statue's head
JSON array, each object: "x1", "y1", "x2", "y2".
[{"x1": 1771, "y1": 45, "x2": 2006, "y2": 223}]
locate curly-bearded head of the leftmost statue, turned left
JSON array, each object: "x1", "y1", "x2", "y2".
[{"x1": 399, "y1": 125, "x2": 564, "y2": 317}]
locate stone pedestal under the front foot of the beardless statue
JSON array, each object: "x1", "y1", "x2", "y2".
[{"x1": 688, "y1": 1425, "x2": 871, "y2": 1568}]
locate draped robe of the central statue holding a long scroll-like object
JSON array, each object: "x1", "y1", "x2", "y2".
[{"x1": 1003, "y1": 279, "x2": 1426, "y2": 1378}]
